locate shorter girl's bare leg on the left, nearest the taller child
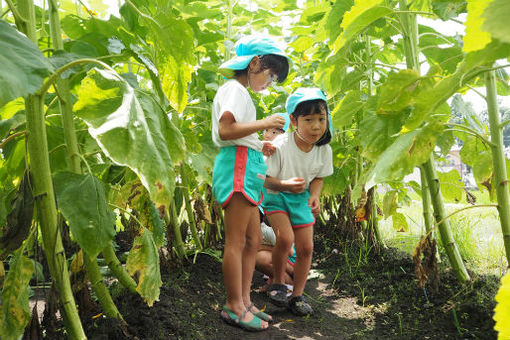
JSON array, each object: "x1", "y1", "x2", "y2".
[{"x1": 268, "y1": 213, "x2": 294, "y2": 283}]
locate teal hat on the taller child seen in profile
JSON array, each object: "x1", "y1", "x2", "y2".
[{"x1": 219, "y1": 35, "x2": 292, "y2": 79}]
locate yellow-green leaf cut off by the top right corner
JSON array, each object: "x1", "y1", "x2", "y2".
[{"x1": 482, "y1": 0, "x2": 510, "y2": 43}]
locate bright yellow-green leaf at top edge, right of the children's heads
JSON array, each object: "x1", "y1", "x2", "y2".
[{"x1": 333, "y1": 0, "x2": 393, "y2": 54}]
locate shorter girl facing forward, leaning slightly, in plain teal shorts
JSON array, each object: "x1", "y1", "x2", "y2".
[{"x1": 262, "y1": 88, "x2": 333, "y2": 315}]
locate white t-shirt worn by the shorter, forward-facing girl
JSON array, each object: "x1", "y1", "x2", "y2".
[{"x1": 266, "y1": 132, "x2": 333, "y2": 192}]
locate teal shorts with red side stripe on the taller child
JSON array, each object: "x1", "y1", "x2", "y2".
[{"x1": 213, "y1": 146, "x2": 267, "y2": 208}]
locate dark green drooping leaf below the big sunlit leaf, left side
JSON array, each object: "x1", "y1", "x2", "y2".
[{"x1": 55, "y1": 172, "x2": 115, "y2": 258}]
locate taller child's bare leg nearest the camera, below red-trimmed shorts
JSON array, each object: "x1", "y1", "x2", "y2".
[{"x1": 222, "y1": 193, "x2": 268, "y2": 327}]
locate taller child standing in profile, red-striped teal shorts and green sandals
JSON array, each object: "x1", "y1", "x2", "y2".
[{"x1": 212, "y1": 36, "x2": 289, "y2": 331}]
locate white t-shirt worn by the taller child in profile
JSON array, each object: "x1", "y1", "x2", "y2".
[{"x1": 212, "y1": 79, "x2": 263, "y2": 151}]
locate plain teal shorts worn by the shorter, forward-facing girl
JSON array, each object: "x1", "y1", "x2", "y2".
[{"x1": 262, "y1": 189, "x2": 315, "y2": 228}]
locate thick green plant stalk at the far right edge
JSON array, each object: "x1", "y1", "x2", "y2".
[{"x1": 485, "y1": 71, "x2": 510, "y2": 266}]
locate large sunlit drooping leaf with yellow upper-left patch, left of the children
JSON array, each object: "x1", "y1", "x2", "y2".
[{"x1": 74, "y1": 69, "x2": 184, "y2": 210}]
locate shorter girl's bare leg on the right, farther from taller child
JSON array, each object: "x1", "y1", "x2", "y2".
[{"x1": 292, "y1": 226, "x2": 313, "y2": 296}]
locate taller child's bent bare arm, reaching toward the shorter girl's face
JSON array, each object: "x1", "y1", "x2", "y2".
[{"x1": 218, "y1": 111, "x2": 285, "y2": 140}]
